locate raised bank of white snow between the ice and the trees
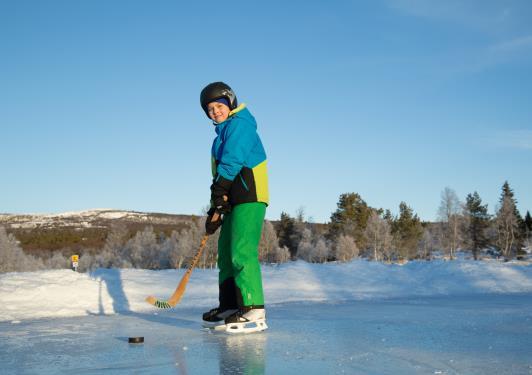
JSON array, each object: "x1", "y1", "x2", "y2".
[{"x1": 0, "y1": 260, "x2": 532, "y2": 322}]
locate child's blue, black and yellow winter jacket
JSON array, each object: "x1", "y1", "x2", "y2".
[{"x1": 212, "y1": 104, "x2": 269, "y2": 205}]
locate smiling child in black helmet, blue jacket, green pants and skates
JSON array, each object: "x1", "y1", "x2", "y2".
[{"x1": 200, "y1": 82, "x2": 269, "y2": 332}]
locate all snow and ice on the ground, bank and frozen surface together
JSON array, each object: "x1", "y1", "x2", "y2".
[{"x1": 0, "y1": 260, "x2": 532, "y2": 374}]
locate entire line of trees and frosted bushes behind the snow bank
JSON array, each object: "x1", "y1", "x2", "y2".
[{"x1": 0, "y1": 182, "x2": 532, "y2": 272}]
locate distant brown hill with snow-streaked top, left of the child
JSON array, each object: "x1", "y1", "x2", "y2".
[{"x1": 0, "y1": 209, "x2": 199, "y2": 255}]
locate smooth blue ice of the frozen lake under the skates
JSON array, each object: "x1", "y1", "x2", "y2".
[{"x1": 0, "y1": 293, "x2": 532, "y2": 375}]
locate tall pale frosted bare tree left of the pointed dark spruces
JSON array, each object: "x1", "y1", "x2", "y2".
[{"x1": 438, "y1": 187, "x2": 462, "y2": 260}]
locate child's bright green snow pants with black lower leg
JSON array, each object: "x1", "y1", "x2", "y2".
[{"x1": 218, "y1": 202, "x2": 266, "y2": 308}]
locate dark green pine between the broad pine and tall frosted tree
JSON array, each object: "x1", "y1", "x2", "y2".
[{"x1": 392, "y1": 202, "x2": 423, "y2": 259}]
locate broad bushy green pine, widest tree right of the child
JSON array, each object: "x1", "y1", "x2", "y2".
[{"x1": 327, "y1": 193, "x2": 372, "y2": 248}]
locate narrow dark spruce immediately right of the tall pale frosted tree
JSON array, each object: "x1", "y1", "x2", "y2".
[{"x1": 465, "y1": 191, "x2": 490, "y2": 260}]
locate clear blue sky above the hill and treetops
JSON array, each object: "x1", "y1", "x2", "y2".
[{"x1": 0, "y1": 0, "x2": 532, "y2": 222}]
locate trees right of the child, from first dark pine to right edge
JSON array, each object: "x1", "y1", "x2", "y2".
[{"x1": 278, "y1": 182, "x2": 532, "y2": 262}]
